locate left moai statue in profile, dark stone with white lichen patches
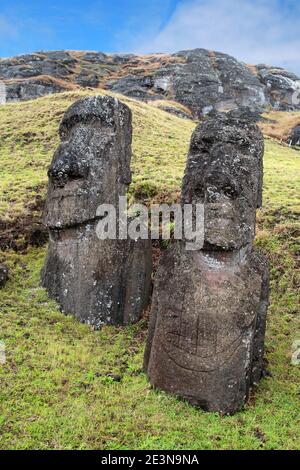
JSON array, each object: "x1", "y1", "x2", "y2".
[{"x1": 42, "y1": 96, "x2": 151, "y2": 328}]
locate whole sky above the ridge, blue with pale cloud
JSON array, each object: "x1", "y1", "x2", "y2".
[{"x1": 0, "y1": 0, "x2": 300, "y2": 75}]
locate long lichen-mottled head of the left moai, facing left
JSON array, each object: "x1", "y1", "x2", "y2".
[{"x1": 44, "y1": 96, "x2": 132, "y2": 229}]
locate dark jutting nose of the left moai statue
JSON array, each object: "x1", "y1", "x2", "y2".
[{"x1": 48, "y1": 152, "x2": 88, "y2": 188}]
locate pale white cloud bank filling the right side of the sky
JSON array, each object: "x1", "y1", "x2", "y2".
[{"x1": 138, "y1": 0, "x2": 300, "y2": 73}]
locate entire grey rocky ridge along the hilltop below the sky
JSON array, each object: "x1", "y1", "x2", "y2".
[{"x1": 0, "y1": 49, "x2": 300, "y2": 118}]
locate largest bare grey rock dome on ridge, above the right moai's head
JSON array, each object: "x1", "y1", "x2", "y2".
[{"x1": 107, "y1": 49, "x2": 268, "y2": 117}]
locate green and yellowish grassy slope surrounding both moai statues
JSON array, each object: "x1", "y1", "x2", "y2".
[{"x1": 0, "y1": 92, "x2": 300, "y2": 449}]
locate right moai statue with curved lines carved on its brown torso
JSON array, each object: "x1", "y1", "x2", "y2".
[{"x1": 144, "y1": 117, "x2": 269, "y2": 414}]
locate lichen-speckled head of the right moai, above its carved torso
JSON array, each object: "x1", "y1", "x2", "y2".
[{"x1": 182, "y1": 116, "x2": 264, "y2": 250}]
